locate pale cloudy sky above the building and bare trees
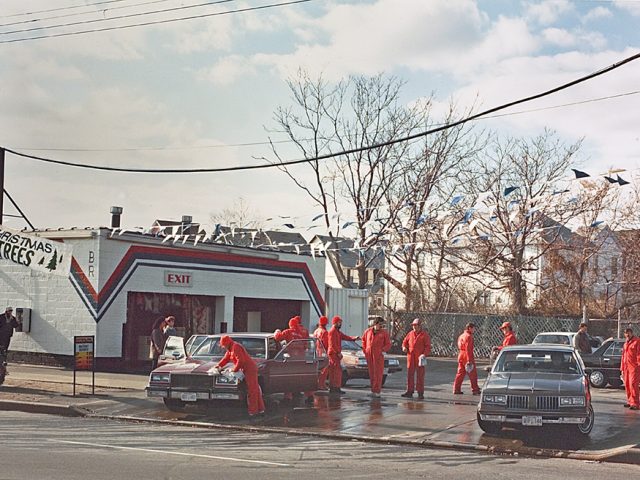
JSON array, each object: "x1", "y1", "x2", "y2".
[{"x1": 0, "y1": 0, "x2": 640, "y2": 233}]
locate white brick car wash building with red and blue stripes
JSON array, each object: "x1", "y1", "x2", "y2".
[{"x1": 0, "y1": 227, "x2": 325, "y2": 370}]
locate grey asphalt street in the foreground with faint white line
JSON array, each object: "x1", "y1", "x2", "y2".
[{"x1": 0, "y1": 412, "x2": 640, "y2": 480}]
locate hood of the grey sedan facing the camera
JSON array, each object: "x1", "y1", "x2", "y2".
[{"x1": 484, "y1": 373, "x2": 584, "y2": 393}]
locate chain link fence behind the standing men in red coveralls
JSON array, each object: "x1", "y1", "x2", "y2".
[{"x1": 390, "y1": 312, "x2": 582, "y2": 358}]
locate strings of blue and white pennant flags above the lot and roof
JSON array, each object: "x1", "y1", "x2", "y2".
[{"x1": 111, "y1": 169, "x2": 631, "y2": 258}]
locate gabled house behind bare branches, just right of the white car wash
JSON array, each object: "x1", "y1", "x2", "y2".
[{"x1": 309, "y1": 235, "x2": 385, "y2": 310}]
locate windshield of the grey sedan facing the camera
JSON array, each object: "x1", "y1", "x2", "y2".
[{"x1": 493, "y1": 350, "x2": 580, "y2": 375}]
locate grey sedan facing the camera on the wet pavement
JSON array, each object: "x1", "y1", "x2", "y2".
[{"x1": 477, "y1": 345, "x2": 594, "y2": 435}]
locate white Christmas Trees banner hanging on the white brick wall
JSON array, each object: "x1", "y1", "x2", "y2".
[{"x1": 0, "y1": 225, "x2": 72, "y2": 277}]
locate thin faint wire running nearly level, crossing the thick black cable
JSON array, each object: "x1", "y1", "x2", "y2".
[{"x1": 15, "y1": 88, "x2": 640, "y2": 152}]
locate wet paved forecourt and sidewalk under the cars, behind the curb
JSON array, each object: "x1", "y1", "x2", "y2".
[{"x1": 0, "y1": 361, "x2": 640, "y2": 464}]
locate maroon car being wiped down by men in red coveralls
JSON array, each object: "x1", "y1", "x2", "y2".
[{"x1": 146, "y1": 333, "x2": 328, "y2": 410}]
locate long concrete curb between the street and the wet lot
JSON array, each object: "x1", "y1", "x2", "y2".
[{"x1": 0, "y1": 400, "x2": 640, "y2": 465}]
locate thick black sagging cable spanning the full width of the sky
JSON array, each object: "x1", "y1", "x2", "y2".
[{"x1": 4, "y1": 53, "x2": 640, "y2": 173}]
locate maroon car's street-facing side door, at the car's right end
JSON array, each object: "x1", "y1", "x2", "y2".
[{"x1": 268, "y1": 338, "x2": 319, "y2": 393}]
